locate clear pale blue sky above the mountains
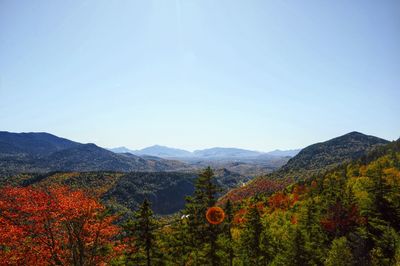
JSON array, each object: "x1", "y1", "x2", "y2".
[{"x1": 0, "y1": 0, "x2": 400, "y2": 151}]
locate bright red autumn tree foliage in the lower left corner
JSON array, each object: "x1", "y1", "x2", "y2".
[{"x1": 0, "y1": 187, "x2": 118, "y2": 265}]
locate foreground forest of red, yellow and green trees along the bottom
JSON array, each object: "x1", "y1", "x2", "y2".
[{"x1": 0, "y1": 140, "x2": 400, "y2": 265}]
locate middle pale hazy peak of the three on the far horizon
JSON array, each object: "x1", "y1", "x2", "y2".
[{"x1": 193, "y1": 147, "x2": 262, "y2": 158}]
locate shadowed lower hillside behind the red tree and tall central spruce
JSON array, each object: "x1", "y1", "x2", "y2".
[{"x1": 0, "y1": 169, "x2": 249, "y2": 215}]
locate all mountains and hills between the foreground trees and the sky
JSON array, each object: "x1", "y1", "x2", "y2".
[{"x1": 0, "y1": 132, "x2": 394, "y2": 214}]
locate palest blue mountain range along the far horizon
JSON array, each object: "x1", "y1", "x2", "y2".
[{"x1": 110, "y1": 145, "x2": 300, "y2": 159}]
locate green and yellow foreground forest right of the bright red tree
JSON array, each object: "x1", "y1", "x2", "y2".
[{"x1": 114, "y1": 141, "x2": 400, "y2": 265}]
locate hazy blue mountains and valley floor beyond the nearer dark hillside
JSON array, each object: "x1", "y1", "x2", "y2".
[{"x1": 0, "y1": 131, "x2": 296, "y2": 178}]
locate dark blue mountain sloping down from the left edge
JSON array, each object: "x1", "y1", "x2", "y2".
[{"x1": 0, "y1": 132, "x2": 187, "y2": 174}]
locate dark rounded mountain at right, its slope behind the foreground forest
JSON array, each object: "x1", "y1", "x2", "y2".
[{"x1": 223, "y1": 132, "x2": 389, "y2": 200}]
